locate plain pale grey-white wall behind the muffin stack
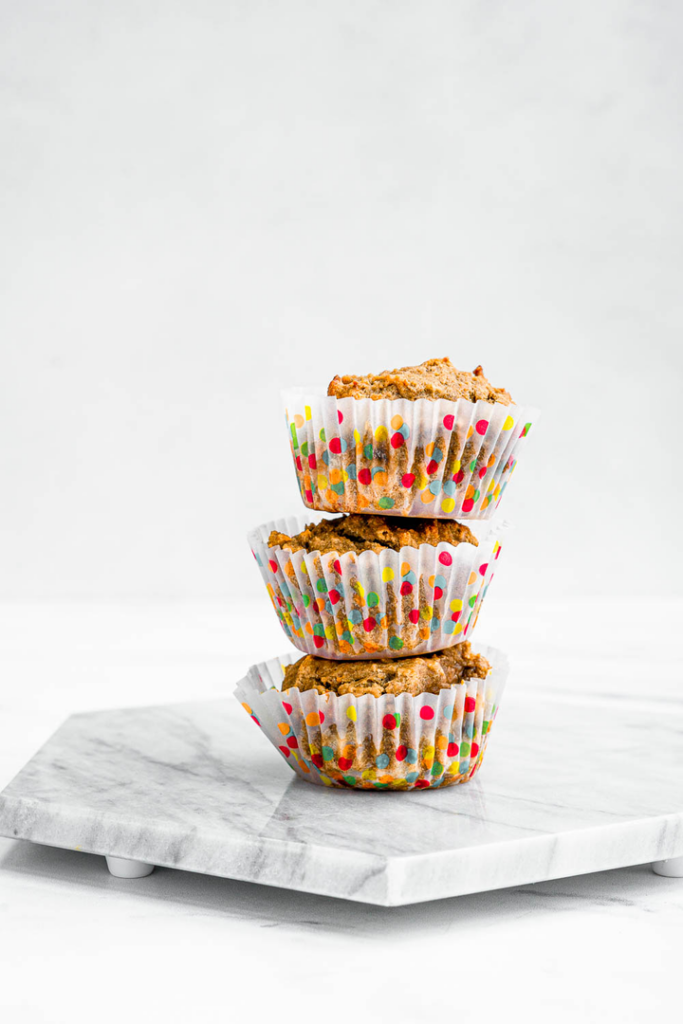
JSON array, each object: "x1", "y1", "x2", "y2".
[{"x1": 0, "y1": 0, "x2": 683, "y2": 612}]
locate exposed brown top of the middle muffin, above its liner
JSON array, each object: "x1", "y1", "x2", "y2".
[{"x1": 268, "y1": 514, "x2": 479, "y2": 555}]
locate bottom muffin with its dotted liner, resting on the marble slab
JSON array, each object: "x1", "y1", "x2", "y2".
[{"x1": 236, "y1": 643, "x2": 508, "y2": 790}]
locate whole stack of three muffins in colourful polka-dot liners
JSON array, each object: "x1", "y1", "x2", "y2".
[{"x1": 237, "y1": 358, "x2": 537, "y2": 790}]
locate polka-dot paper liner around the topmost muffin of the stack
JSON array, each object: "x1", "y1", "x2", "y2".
[{"x1": 283, "y1": 388, "x2": 539, "y2": 519}]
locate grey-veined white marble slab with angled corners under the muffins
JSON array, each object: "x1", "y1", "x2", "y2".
[{"x1": 0, "y1": 681, "x2": 683, "y2": 906}]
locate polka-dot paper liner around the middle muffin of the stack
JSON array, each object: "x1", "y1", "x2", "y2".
[{"x1": 249, "y1": 516, "x2": 507, "y2": 660}]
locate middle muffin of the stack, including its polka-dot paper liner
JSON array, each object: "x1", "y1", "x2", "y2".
[{"x1": 249, "y1": 515, "x2": 505, "y2": 659}]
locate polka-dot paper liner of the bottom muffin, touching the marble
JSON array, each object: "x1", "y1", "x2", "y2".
[{"x1": 234, "y1": 646, "x2": 508, "y2": 790}]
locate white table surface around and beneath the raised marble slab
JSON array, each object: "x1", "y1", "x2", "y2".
[{"x1": 0, "y1": 599, "x2": 683, "y2": 1024}]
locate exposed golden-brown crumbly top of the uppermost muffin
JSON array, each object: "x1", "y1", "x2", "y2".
[{"x1": 328, "y1": 357, "x2": 512, "y2": 406}]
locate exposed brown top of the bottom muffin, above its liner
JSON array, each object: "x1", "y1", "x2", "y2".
[{"x1": 282, "y1": 640, "x2": 490, "y2": 697}]
